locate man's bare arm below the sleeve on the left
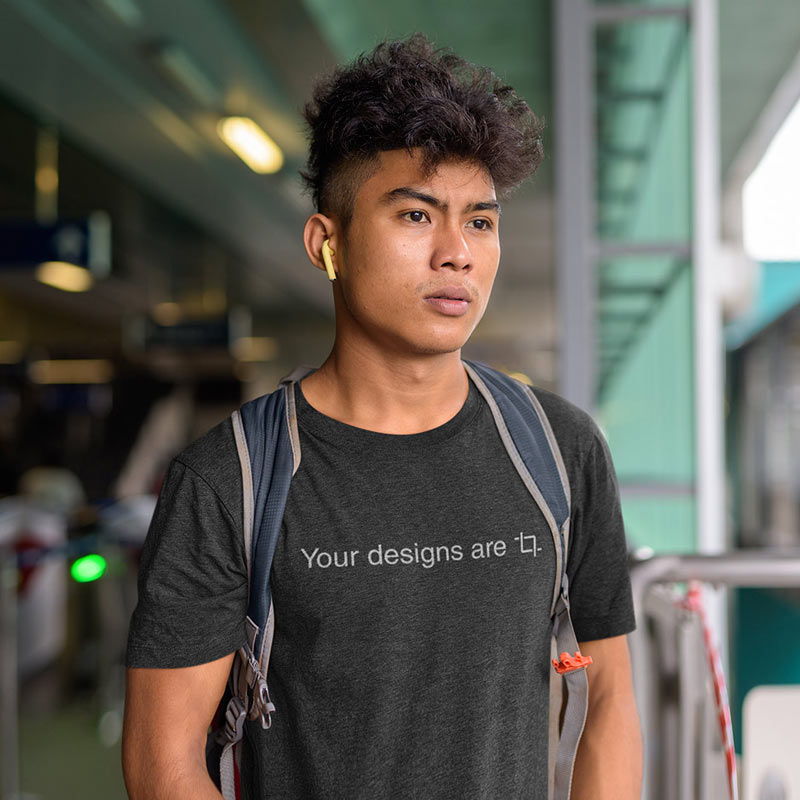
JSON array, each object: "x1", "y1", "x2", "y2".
[{"x1": 122, "y1": 654, "x2": 233, "y2": 800}]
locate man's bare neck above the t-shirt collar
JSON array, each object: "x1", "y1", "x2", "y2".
[{"x1": 302, "y1": 345, "x2": 469, "y2": 434}]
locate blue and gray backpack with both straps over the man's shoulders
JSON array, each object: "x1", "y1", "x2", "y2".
[{"x1": 207, "y1": 361, "x2": 591, "y2": 800}]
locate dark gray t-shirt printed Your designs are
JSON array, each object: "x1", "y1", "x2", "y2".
[{"x1": 128, "y1": 376, "x2": 633, "y2": 800}]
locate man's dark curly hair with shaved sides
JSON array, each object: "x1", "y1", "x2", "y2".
[{"x1": 301, "y1": 34, "x2": 542, "y2": 226}]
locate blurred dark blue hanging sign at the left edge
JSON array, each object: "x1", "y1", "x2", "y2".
[{"x1": 0, "y1": 211, "x2": 111, "y2": 278}]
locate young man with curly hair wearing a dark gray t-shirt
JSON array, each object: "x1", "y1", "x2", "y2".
[{"x1": 124, "y1": 37, "x2": 640, "y2": 800}]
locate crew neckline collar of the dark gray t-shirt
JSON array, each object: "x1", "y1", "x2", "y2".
[{"x1": 294, "y1": 379, "x2": 481, "y2": 448}]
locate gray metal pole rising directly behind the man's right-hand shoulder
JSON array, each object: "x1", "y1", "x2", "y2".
[{"x1": 553, "y1": 0, "x2": 597, "y2": 411}]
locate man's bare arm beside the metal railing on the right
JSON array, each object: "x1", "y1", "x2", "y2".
[{"x1": 572, "y1": 636, "x2": 642, "y2": 800}]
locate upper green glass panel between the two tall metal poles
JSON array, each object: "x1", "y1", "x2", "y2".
[{"x1": 595, "y1": 16, "x2": 691, "y2": 242}]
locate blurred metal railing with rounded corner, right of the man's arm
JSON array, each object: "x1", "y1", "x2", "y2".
[{"x1": 630, "y1": 549, "x2": 800, "y2": 800}]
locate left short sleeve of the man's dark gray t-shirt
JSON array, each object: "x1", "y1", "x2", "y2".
[{"x1": 126, "y1": 424, "x2": 247, "y2": 668}]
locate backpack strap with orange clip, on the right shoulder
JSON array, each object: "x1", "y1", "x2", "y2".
[{"x1": 464, "y1": 361, "x2": 589, "y2": 800}]
